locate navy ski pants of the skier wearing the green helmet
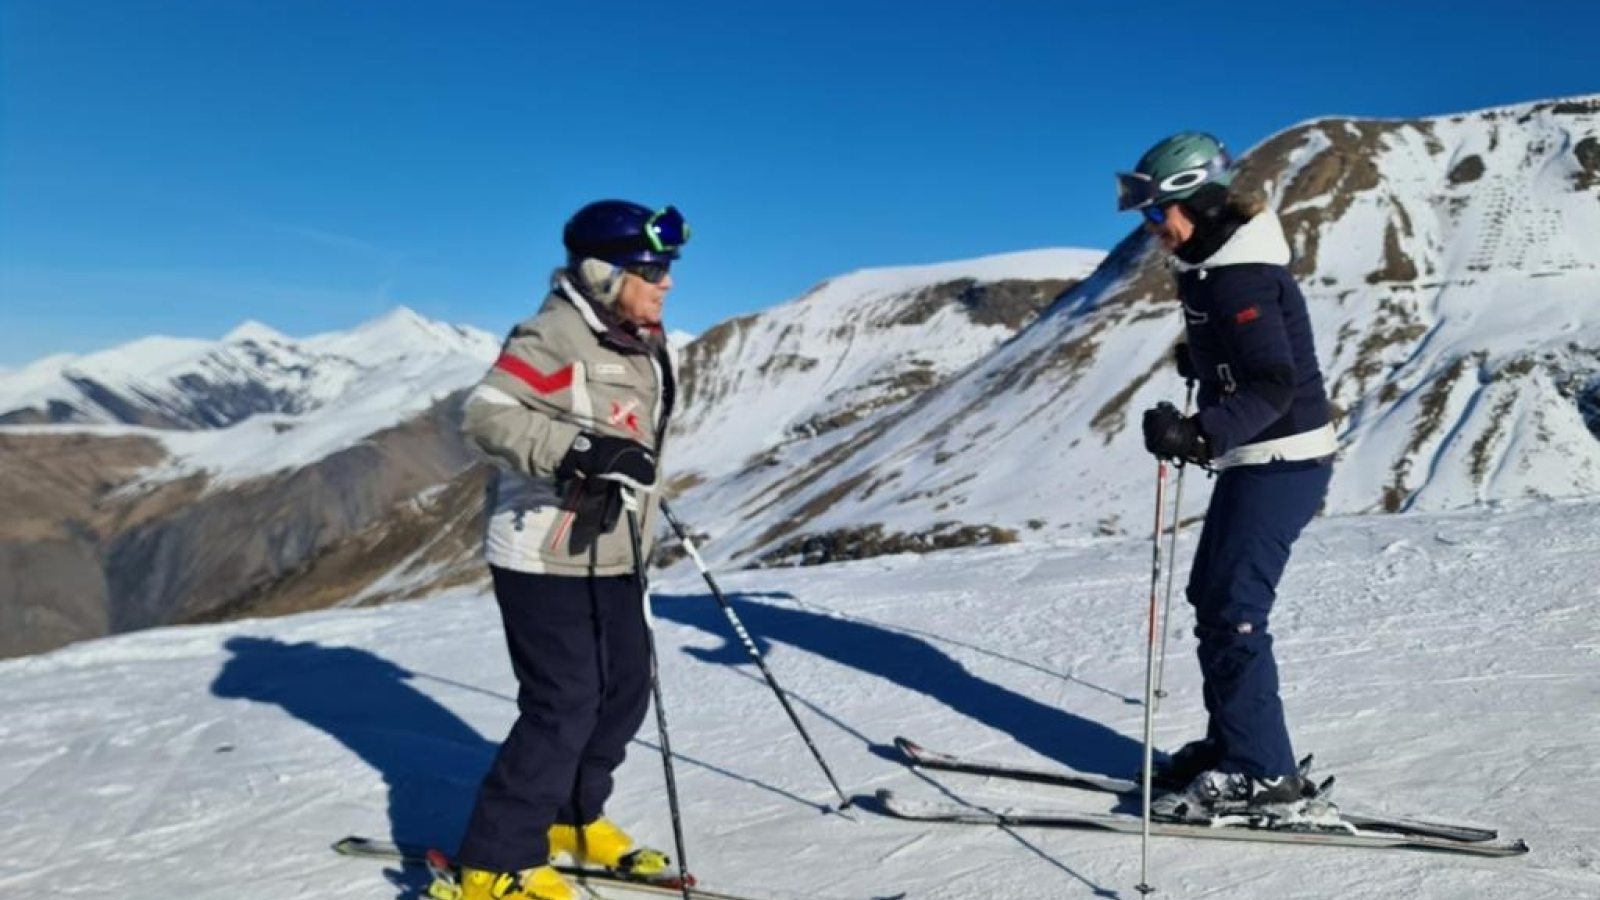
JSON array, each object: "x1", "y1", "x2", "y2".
[{"x1": 1189, "y1": 460, "x2": 1333, "y2": 778}]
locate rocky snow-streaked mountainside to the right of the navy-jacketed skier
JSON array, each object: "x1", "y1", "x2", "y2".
[{"x1": 1248, "y1": 96, "x2": 1600, "y2": 511}]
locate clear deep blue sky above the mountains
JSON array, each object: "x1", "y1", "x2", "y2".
[{"x1": 0, "y1": 0, "x2": 1600, "y2": 367}]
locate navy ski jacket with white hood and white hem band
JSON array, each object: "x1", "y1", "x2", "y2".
[{"x1": 1176, "y1": 211, "x2": 1333, "y2": 458}]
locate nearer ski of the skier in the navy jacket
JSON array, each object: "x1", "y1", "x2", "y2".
[{"x1": 877, "y1": 790, "x2": 1528, "y2": 857}]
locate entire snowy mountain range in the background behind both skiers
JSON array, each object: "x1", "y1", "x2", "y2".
[{"x1": 0, "y1": 91, "x2": 1600, "y2": 655}]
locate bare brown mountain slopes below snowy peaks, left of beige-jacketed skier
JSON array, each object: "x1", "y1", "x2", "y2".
[{"x1": 0, "y1": 385, "x2": 482, "y2": 655}]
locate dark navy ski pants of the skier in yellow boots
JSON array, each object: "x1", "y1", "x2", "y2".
[{"x1": 458, "y1": 567, "x2": 650, "y2": 871}]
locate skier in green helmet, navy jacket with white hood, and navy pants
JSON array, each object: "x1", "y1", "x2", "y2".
[{"x1": 1118, "y1": 133, "x2": 1338, "y2": 818}]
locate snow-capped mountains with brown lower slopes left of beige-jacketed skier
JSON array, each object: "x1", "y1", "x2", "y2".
[{"x1": 0, "y1": 309, "x2": 498, "y2": 655}]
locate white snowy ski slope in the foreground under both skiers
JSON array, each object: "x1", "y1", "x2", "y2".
[{"x1": 0, "y1": 500, "x2": 1600, "y2": 900}]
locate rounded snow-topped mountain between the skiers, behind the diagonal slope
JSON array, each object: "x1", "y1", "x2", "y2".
[{"x1": 672, "y1": 250, "x2": 1104, "y2": 477}]
